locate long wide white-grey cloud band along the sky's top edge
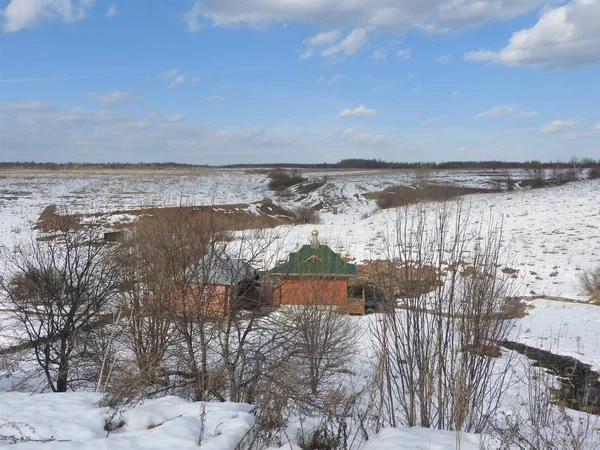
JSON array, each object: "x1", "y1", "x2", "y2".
[{"x1": 188, "y1": 0, "x2": 544, "y2": 32}]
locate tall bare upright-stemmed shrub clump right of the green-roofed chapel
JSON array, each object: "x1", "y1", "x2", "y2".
[{"x1": 374, "y1": 202, "x2": 511, "y2": 432}]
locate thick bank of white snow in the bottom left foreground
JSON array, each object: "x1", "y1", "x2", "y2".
[{"x1": 0, "y1": 392, "x2": 254, "y2": 450}]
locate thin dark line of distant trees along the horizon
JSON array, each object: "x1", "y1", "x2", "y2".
[{"x1": 0, "y1": 158, "x2": 600, "y2": 170}]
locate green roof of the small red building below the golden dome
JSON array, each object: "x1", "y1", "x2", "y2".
[{"x1": 271, "y1": 245, "x2": 356, "y2": 277}]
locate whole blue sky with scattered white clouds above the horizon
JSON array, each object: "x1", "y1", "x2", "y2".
[{"x1": 0, "y1": 0, "x2": 600, "y2": 164}]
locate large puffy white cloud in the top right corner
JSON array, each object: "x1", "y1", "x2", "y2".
[{"x1": 464, "y1": 0, "x2": 600, "y2": 67}]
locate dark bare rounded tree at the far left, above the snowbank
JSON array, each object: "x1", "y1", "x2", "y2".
[{"x1": 0, "y1": 227, "x2": 123, "y2": 392}]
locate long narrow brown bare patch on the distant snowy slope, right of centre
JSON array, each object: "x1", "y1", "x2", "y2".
[{"x1": 364, "y1": 184, "x2": 495, "y2": 209}]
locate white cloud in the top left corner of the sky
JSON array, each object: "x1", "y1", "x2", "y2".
[{"x1": 0, "y1": 0, "x2": 93, "y2": 33}]
